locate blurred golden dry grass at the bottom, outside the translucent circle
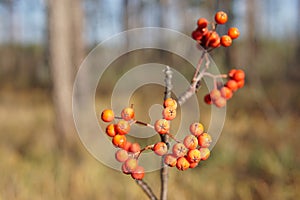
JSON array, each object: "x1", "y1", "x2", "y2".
[{"x1": 0, "y1": 80, "x2": 300, "y2": 200}]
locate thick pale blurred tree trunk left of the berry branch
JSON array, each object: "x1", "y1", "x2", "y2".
[{"x1": 48, "y1": 0, "x2": 84, "y2": 148}]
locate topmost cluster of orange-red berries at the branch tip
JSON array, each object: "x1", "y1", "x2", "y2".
[{"x1": 192, "y1": 11, "x2": 240, "y2": 49}]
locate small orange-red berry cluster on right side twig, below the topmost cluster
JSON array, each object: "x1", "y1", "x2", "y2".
[{"x1": 204, "y1": 69, "x2": 245, "y2": 108}]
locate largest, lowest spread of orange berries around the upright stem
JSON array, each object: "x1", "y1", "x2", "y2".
[{"x1": 101, "y1": 98, "x2": 212, "y2": 180}]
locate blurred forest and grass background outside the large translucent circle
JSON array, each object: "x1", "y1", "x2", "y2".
[{"x1": 0, "y1": 0, "x2": 300, "y2": 200}]
